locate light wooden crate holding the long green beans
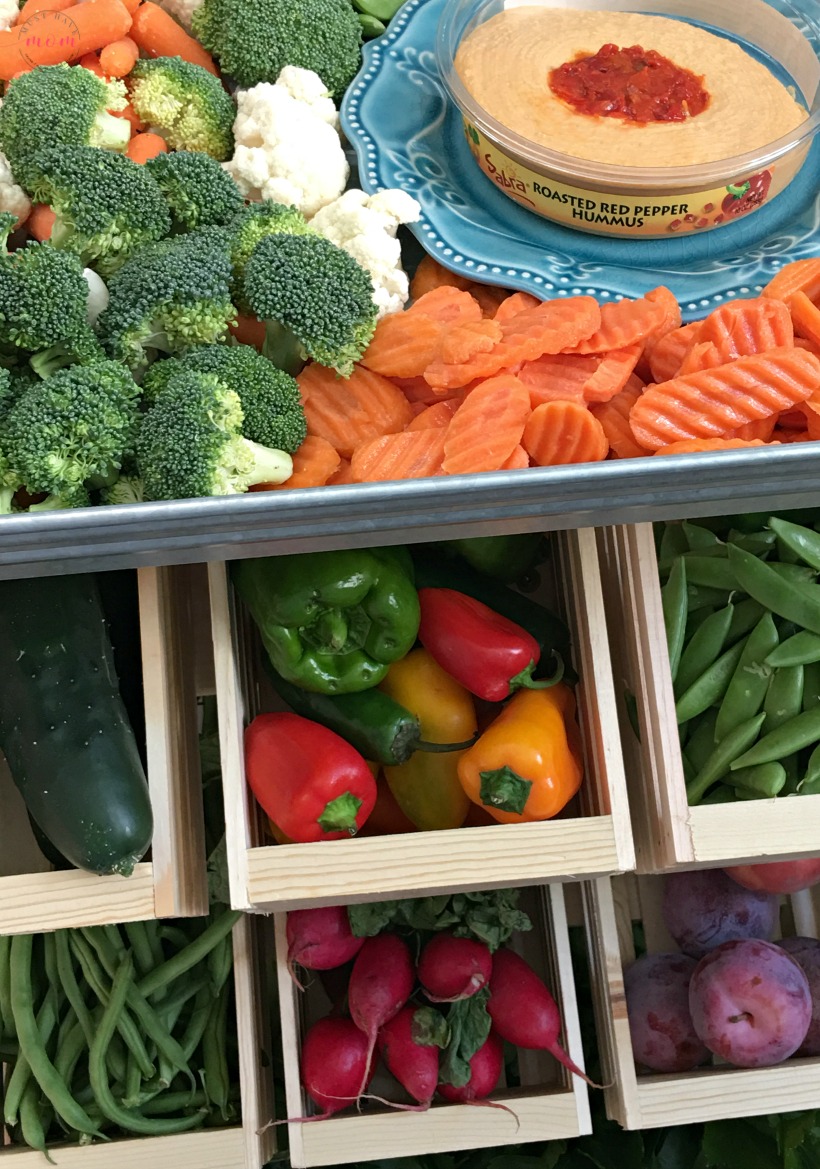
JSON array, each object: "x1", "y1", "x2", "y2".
[{"x1": 0, "y1": 916, "x2": 276, "y2": 1169}]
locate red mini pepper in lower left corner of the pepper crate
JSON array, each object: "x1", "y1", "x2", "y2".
[{"x1": 244, "y1": 712, "x2": 377, "y2": 844}]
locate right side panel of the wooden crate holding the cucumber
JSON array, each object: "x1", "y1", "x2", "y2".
[{"x1": 137, "y1": 568, "x2": 208, "y2": 916}]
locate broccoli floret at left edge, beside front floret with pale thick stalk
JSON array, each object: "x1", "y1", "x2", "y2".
[{"x1": 2, "y1": 361, "x2": 139, "y2": 507}]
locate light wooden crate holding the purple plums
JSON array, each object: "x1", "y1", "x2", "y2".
[{"x1": 584, "y1": 874, "x2": 820, "y2": 1128}]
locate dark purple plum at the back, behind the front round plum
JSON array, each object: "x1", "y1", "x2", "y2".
[{"x1": 662, "y1": 869, "x2": 779, "y2": 957}]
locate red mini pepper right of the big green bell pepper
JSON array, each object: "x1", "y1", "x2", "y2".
[{"x1": 419, "y1": 588, "x2": 564, "y2": 703}]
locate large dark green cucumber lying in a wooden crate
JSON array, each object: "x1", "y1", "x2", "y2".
[{"x1": 0, "y1": 575, "x2": 153, "y2": 877}]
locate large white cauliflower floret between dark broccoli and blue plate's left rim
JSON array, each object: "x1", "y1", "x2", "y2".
[{"x1": 223, "y1": 65, "x2": 350, "y2": 217}]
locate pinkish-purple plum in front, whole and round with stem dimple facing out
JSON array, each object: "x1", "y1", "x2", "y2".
[{"x1": 689, "y1": 940, "x2": 812, "y2": 1067}]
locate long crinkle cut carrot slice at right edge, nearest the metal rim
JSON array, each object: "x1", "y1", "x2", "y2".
[{"x1": 629, "y1": 348, "x2": 820, "y2": 450}]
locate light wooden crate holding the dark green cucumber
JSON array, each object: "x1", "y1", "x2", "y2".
[{"x1": 0, "y1": 568, "x2": 208, "y2": 934}]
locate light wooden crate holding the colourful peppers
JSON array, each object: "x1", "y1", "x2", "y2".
[{"x1": 204, "y1": 530, "x2": 634, "y2": 912}]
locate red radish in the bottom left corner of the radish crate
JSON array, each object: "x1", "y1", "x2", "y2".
[{"x1": 302, "y1": 1018, "x2": 373, "y2": 1119}]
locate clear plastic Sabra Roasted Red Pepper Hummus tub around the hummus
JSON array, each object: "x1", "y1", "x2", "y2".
[{"x1": 435, "y1": 0, "x2": 820, "y2": 238}]
